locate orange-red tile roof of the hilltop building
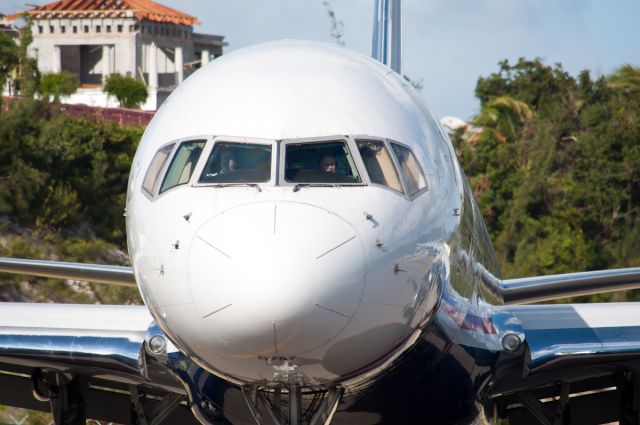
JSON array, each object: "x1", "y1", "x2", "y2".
[{"x1": 8, "y1": 0, "x2": 200, "y2": 25}]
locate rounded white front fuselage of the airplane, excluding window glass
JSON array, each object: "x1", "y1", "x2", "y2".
[{"x1": 127, "y1": 42, "x2": 463, "y2": 385}]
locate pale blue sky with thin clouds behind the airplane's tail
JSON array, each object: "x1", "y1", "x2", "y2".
[{"x1": 0, "y1": 0, "x2": 640, "y2": 120}]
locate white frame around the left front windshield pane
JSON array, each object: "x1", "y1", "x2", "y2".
[{"x1": 191, "y1": 136, "x2": 278, "y2": 187}]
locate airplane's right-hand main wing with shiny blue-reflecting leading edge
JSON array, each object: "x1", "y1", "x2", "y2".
[{"x1": 489, "y1": 303, "x2": 640, "y2": 424}]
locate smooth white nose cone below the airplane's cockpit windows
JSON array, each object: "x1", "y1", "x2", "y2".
[{"x1": 188, "y1": 201, "x2": 365, "y2": 357}]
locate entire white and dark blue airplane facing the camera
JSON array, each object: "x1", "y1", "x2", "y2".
[{"x1": 0, "y1": 0, "x2": 640, "y2": 425}]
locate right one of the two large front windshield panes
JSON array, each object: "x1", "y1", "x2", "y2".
[{"x1": 285, "y1": 140, "x2": 361, "y2": 184}]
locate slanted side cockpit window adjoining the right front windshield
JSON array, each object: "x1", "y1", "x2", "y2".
[{"x1": 357, "y1": 140, "x2": 402, "y2": 193}]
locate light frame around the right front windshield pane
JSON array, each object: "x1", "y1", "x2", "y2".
[{"x1": 277, "y1": 135, "x2": 369, "y2": 187}]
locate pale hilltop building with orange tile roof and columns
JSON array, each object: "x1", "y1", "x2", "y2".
[{"x1": 9, "y1": 0, "x2": 225, "y2": 110}]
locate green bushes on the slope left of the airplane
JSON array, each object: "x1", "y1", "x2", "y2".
[{"x1": 0, "y1": 98, "x2": 142, "y2": 302}]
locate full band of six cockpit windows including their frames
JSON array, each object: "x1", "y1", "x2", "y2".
[{"x1": 142, "y1": 136, "x2": 428, "y2": 200}]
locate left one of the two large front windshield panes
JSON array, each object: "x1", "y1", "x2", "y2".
[{"x1": 200, "y1": 142, "x2": 271, "y2": 183}]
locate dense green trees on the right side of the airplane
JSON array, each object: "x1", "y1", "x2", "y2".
[{"x1": 454, "y1": 59, "x2": 640, "y2": 299}]
